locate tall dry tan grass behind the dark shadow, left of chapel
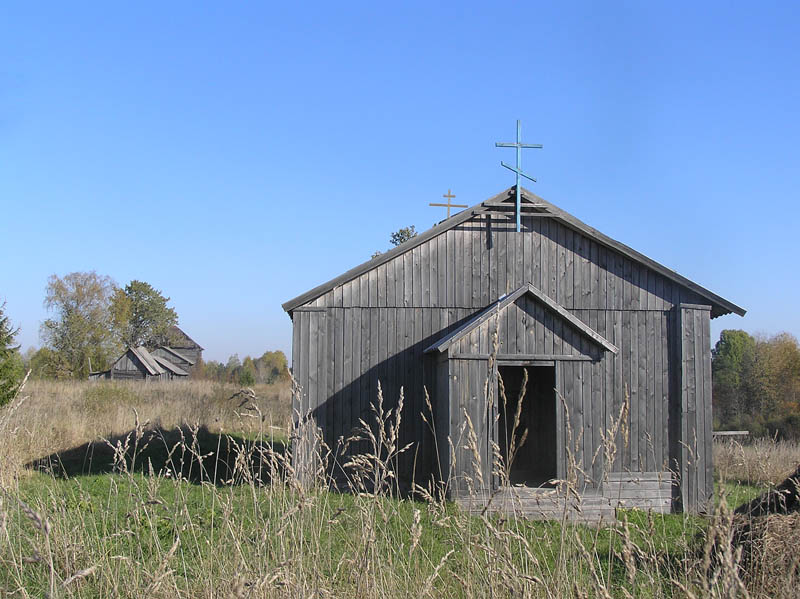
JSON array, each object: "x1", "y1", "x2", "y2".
[{"x1": 0, "y1": 380, "x2": 291, "y2": 488}]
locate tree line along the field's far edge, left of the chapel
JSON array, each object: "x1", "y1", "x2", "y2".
[{"x1": 0, "y1": 271, "x2": 288, "y2": 405}]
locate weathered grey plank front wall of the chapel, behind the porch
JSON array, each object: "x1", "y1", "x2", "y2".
[{"x1": 292, "y1": 215, "x2": 707, "y2": 508}]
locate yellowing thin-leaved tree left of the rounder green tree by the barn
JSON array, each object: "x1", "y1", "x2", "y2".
[{"x1": 40, "y1": 271, "x2": 120, "y2": 379}]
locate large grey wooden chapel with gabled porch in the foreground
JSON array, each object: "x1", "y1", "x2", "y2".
[{"x1": 283, "y1": 187, "x2": 745, "y2": 511}]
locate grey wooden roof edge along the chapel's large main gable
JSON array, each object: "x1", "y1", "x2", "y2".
[{"x1": 282, "y1": 186, "x2": 746, "y2": 318}]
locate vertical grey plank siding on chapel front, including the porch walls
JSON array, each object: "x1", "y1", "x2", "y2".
[{"x1": 292, "y1": 214, "x2": 712, "y2": 510}]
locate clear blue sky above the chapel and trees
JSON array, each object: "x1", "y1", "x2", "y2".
[{"x1": 0, "y1": 2, "x2": 800, "y2": 359}]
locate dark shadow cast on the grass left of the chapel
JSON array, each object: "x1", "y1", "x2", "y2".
[{"x1": 26, "y1": 427, "x2": 289, "y2": 486}]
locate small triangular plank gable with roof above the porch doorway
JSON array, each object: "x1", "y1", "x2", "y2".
[{"x1": 425, "y1": 284, "x2": 619, "y2": 356}]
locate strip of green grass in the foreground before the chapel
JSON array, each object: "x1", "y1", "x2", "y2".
[{"x1": 0, "y1": 472, "x2": 716, "y2": 596}]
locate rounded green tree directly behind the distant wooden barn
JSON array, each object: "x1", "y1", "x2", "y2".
[{"x1": 111, "y1": 280, "x2": 178, "y2": 349}]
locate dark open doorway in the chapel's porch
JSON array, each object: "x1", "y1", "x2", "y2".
[{"x1": 498, "y1": 366, "x2": 557, "y2": 487}]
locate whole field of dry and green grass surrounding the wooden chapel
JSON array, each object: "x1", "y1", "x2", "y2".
[{"x1": 0, "y1": 382, "x2": 800, "y2": 597}]
